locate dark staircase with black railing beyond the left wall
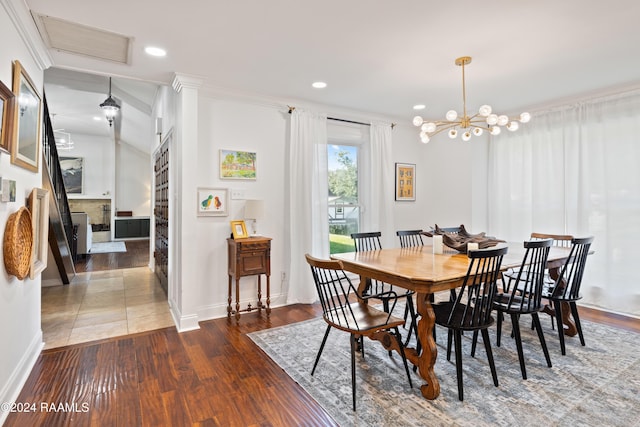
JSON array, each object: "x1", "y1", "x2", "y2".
[{"x1": 42, "y1": 95, "x2": 76, "y2": 285}]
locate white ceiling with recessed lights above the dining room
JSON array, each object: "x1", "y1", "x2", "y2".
[{"x1": 26, "y1": 0, "x2": 640, "y2": 152}]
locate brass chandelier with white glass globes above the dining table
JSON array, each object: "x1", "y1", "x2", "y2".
[{"x1": 413, "y1": 56, "x2": 531, "y2": 144}]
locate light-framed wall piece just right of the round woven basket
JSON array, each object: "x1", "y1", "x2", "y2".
[{"x1": 29, "y1": 188, "x2": 49, "y2": 279}]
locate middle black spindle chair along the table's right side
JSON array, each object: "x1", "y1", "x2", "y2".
[{"x1": 482, "y1": 239, "x2": 553, "y2": 380}]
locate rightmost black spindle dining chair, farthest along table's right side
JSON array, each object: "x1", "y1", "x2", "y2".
[{"x1": 542, "y1": 236, "x2": 594, "y2": 356}]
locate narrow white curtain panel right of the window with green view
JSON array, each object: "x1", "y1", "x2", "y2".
[{"x1": 362, "y1": 123, "x2": 396, "y2": 248}]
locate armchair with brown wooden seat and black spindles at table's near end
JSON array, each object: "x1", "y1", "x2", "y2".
[{"x1": 305, "y1": 254, "x2": 413, "y2": 411}]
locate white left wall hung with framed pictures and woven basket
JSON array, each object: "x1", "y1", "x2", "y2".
[{"x1": 0, "y1": 0, "x2": 43, "y2": 423}]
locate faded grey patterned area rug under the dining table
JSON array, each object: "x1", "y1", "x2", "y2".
[{"x1": 249, "y1": 307, "x2": 640, "y2": 426}]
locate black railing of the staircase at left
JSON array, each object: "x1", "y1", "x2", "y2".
[{"x1": 42, "y1": 95, "x2": 76, "y2": 259}]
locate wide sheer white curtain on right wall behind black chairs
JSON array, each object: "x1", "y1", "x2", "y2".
[{"x1": 489, "y1": 92, "x2": 640, "y2": 316}]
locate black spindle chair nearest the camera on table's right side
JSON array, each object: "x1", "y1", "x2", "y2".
[{"x1": 433, "y1": 246, "x2": 508, "y2": 400}]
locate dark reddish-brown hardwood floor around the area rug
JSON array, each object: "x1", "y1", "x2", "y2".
[{"x1": 5, "y1": 298, "x2": 640, "y2": 426}]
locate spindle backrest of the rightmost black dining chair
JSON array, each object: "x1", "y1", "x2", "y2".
[{"x1": 551, "y1": 236, "x2": 594, "y2": 301}]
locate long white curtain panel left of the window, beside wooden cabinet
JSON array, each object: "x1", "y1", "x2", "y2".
[{"x1": 287, "y1": 109, "x2": 329, "y2": 304}]
